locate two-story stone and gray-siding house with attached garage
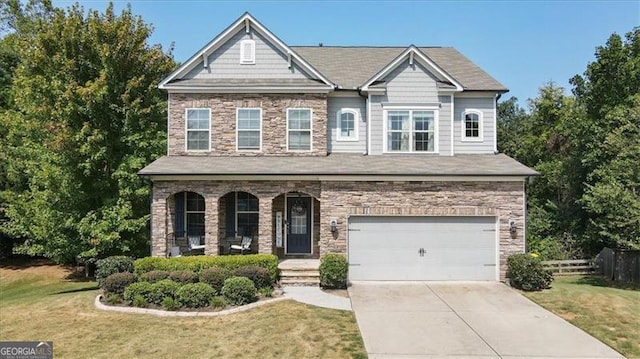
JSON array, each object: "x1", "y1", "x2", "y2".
[{"x1": 140, "y1": 13, "x2": 536, "y2": 280}]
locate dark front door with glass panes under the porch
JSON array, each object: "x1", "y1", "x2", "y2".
[{"x1": 287, "y1": 197, "x2": 311, "y2": 254}]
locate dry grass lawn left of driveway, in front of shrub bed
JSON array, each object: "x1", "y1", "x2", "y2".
[{"x1": 0, "y1": 264, "x2": 366, "y2": 358}]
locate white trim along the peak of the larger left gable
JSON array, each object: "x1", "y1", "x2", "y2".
[{"x1": 158, "y1": 12, "x2": 336, "y2": 89}]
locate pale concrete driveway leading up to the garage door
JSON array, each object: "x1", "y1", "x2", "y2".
[{"x1": 349, "y1": 282, "x2": 622, "y2": 359}]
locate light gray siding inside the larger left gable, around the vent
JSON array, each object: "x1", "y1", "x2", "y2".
[{"x1": 184, "y1": 29, "x2": 308, "y2": 79}]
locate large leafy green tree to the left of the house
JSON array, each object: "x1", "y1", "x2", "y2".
[{"x1": 0, "y1": 1, "x2": 175, "y2": 262}]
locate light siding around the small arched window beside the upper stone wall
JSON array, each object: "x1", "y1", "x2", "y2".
[{"x1": 327, "y1": 96, "x2": 367, "y2": 153}]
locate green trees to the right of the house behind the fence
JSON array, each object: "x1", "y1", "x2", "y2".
[{"x1": 498, "y1": 28, "x2": 640, "y2": 259}]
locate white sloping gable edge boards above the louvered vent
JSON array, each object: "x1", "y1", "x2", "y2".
[{"x1": 158, "y1": 13, "x2": 335, "y2": 89}]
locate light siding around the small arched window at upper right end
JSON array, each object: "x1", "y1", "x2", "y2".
[{"x1": 453, "y1": 97, "x2": 496, "y2": 154}]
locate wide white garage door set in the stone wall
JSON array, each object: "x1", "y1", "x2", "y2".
[{"x1": 348, "y1": 217, "x2": 497, "y2": 281}]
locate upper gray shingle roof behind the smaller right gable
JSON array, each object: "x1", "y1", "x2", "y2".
[{"x1": 291, "y1": 46, "x2": 508, "y2": 92}]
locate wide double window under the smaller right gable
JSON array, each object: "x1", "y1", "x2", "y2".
[{"x1": 386, "y1": 110, "x2": 437, "y2": 152}]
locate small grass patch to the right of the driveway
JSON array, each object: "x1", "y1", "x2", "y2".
[{"x1": 523, "y1": 276, "x2": 640, "y2": 358}]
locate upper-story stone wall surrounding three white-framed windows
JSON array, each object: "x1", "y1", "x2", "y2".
[{"x1": 168, "y1": 93, "x2": 327, "y2": 156}]
